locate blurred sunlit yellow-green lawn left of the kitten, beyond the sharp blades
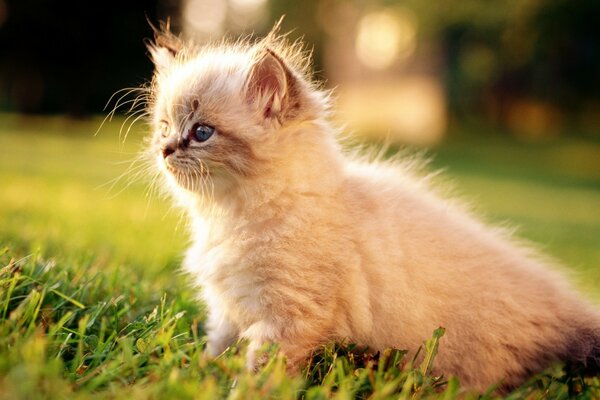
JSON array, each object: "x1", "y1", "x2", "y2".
[{"x1": 0, "y1": 114, "x2": 185, "y2": 269}]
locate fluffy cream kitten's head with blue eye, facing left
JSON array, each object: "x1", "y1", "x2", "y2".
[{"x1": 148, "y1": 25, "x2": 327, "y2": 198}]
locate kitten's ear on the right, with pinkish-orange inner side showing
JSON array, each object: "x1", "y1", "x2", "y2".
[{"x1": 246, "y1": 49, "x2": 295, "y2": 121}]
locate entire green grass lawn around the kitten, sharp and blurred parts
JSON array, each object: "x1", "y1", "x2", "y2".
[{"x1": 0, "y1": 116, "x2": 600, "y2": 399}]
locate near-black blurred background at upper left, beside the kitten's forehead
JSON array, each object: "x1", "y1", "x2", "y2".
[{"x1": 0, "y1": 0, "x2": 177, "y2": 116}]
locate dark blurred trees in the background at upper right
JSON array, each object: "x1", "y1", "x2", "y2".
[{"x1": 436, "y1": 0, "x2": 600, "y2": 125}]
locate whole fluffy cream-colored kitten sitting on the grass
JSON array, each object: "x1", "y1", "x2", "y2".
[{"x1": 149, "y1": 26, "x2": 600, "y2": 389}]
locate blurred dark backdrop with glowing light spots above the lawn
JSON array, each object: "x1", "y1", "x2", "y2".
[{"x1": 0, "y1": 0, "x2": 600, "y2": 145}]
